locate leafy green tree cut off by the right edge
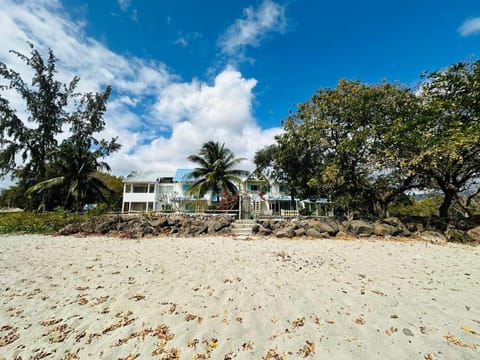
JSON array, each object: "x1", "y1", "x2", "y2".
[{"x1": 414, "y1": 61, "x2": 480, "y2": 217}]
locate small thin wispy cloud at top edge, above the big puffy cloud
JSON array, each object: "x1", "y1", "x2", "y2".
[{"x1": 219, "y1": 0, "x2": 287, "y2": 56}]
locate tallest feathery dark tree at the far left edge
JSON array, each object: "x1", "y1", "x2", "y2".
[{"x1": 0, "y1": 44, "x2": 79, "y2": 205}]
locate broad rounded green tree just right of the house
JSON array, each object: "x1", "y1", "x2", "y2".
[{"x1": 257, "y1": 80, "x2": 420, "y2": 216}]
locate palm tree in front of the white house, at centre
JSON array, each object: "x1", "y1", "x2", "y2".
[{"x1": 187, "y1": 141, "x2": 248, "y2": 202}]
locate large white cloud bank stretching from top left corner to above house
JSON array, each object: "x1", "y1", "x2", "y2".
[{"x1": 0, "y1": 0, "x2": 280, "y2": 187}]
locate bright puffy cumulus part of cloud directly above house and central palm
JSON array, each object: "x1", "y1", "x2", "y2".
[{"x1": 107, "y1": 68, "x2": 280, "y2": 176}]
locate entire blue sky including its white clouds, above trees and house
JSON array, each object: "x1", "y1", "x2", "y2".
[{"x1": 0, "y1": 0, "x2": 480, "y2": 181}]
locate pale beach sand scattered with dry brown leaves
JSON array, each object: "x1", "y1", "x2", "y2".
[{"x1": 0, "y1": 235, "x2": 480, "y2": 359}]
